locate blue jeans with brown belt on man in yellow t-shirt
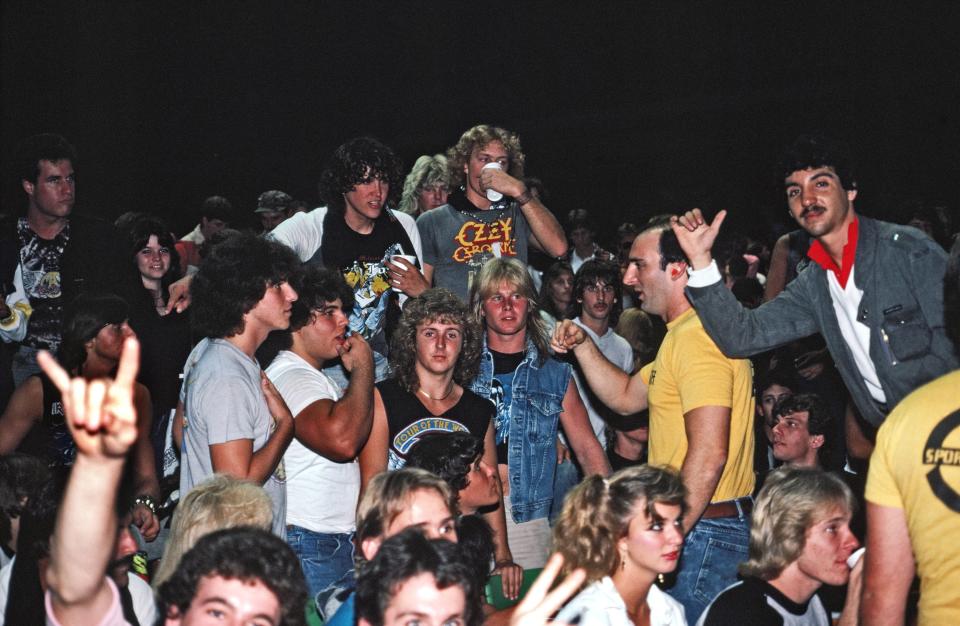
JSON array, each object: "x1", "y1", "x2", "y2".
[{"x1": 667, "y1": 512, "x2": 750, "y2": 624}]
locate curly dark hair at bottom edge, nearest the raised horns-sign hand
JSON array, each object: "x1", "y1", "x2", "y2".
[{"x1": 157, "y1": 527, "x2": 307, "y2": 626}]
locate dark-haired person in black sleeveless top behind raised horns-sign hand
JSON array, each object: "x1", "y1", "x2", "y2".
[{"x1": 0, "y1": 295, "x2": 160, "y2": 541}]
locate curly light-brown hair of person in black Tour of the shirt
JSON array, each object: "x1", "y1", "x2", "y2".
[{"x1": 390, "y1": 288, "x2": 483, "y2": 393}]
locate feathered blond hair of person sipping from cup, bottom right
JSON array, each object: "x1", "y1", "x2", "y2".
[{"x1": 740, "y1": 467, "x2": 857, "y2": 580}]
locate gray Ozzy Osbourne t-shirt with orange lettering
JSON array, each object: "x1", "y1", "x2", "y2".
[{"x1": 417, "y1": 194, "x2": 530, "y2": 302}]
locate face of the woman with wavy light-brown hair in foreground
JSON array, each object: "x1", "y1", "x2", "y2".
[{"x1": 617, "y1": 498, "x2": 683, "y2": 578}]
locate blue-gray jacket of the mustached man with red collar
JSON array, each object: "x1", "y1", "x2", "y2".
[{"x1": 687, "y1": 215, "x2": 960, "y2": 426}]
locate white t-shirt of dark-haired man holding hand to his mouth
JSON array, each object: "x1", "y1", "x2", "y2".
[{"x1": 267, "y1": 350, "x2": 360, "y2": 533}]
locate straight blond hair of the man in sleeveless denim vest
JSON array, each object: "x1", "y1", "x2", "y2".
[{"x1": 470, "y1": 257, "x2": 550, "y2": 362}]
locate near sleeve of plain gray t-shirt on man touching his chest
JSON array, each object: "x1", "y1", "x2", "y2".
[{"x1": 194, "y1": 376, "x2": 263, "y2": 446}]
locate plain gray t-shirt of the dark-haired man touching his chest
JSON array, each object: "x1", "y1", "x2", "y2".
[{"x1": 180, "y1": 339, "x2": 287, "y2": 538}]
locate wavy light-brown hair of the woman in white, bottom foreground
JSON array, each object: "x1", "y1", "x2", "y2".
[{"x1": 553, "y1": 465, "x2": 687, "y2": 584}]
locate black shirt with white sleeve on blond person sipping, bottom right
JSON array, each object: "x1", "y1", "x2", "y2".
[{"x1": 701, "y1": 578, "x2": 830, "y2": 626}]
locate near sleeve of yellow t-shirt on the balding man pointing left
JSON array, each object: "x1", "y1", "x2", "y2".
[{"x1": 675, "y1": 328, "x2": 733, "y2": 414}]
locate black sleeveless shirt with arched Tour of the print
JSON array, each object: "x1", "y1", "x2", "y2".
[{"x1": 377, "y1": 378, "x2": 494, "y2": 470}]
